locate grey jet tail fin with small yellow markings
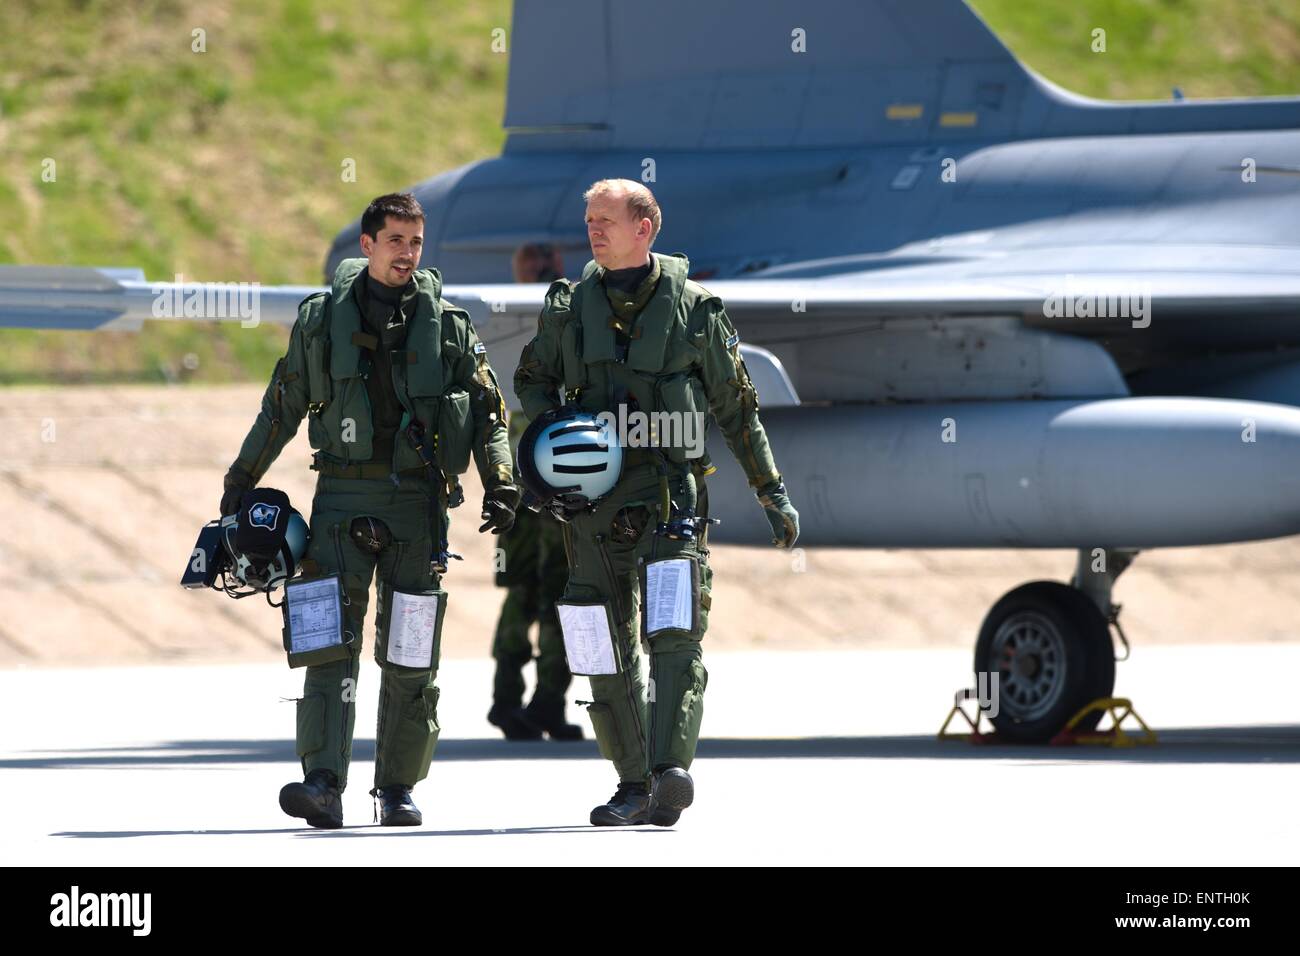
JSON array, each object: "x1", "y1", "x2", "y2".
[{"x1": 506, "y1": 0, "x2": 1300, "y2": 156}]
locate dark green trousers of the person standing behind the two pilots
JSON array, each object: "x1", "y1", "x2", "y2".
[{"x1": 491, "y1": 415, "x2": 573, "y2": 710}]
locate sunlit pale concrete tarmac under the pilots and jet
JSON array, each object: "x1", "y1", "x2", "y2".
[{"x1": 0, "y1": 644, "x2": 1300, "y2": 866}]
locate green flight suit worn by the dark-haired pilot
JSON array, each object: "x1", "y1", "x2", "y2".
[{"x1": 234, "y1": 259, "x2": 514, "y2": 788}]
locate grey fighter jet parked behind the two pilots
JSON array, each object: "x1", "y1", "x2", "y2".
[{"x1": 0, "y1": 0, "x2": 1300, "y2": 741}]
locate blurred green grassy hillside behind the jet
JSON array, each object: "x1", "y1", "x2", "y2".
[{"x1": 0, "y1": 0, "x2": 1300, "y2": 382}]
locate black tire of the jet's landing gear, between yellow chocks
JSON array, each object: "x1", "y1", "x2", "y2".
[{"x1": 975, "y1": 581, "x2": 1115, "y2": 744}]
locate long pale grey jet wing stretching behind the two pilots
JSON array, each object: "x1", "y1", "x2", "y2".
[{"x1": 0, "y1": 245, "x2": 1300, "y2": 341}]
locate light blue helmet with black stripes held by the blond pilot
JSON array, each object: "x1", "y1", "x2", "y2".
[{"x1": 519, "y1": 406, "x2": 623, "y2": 510}]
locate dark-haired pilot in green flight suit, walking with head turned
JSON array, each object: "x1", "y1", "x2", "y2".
[{"x1": 221, "y1": 194, "x2": 519, "y2": 827}]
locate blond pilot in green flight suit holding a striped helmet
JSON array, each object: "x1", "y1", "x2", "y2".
[{"x1": 515, "y1": 179, "x2": 798, "y2": 826}]
